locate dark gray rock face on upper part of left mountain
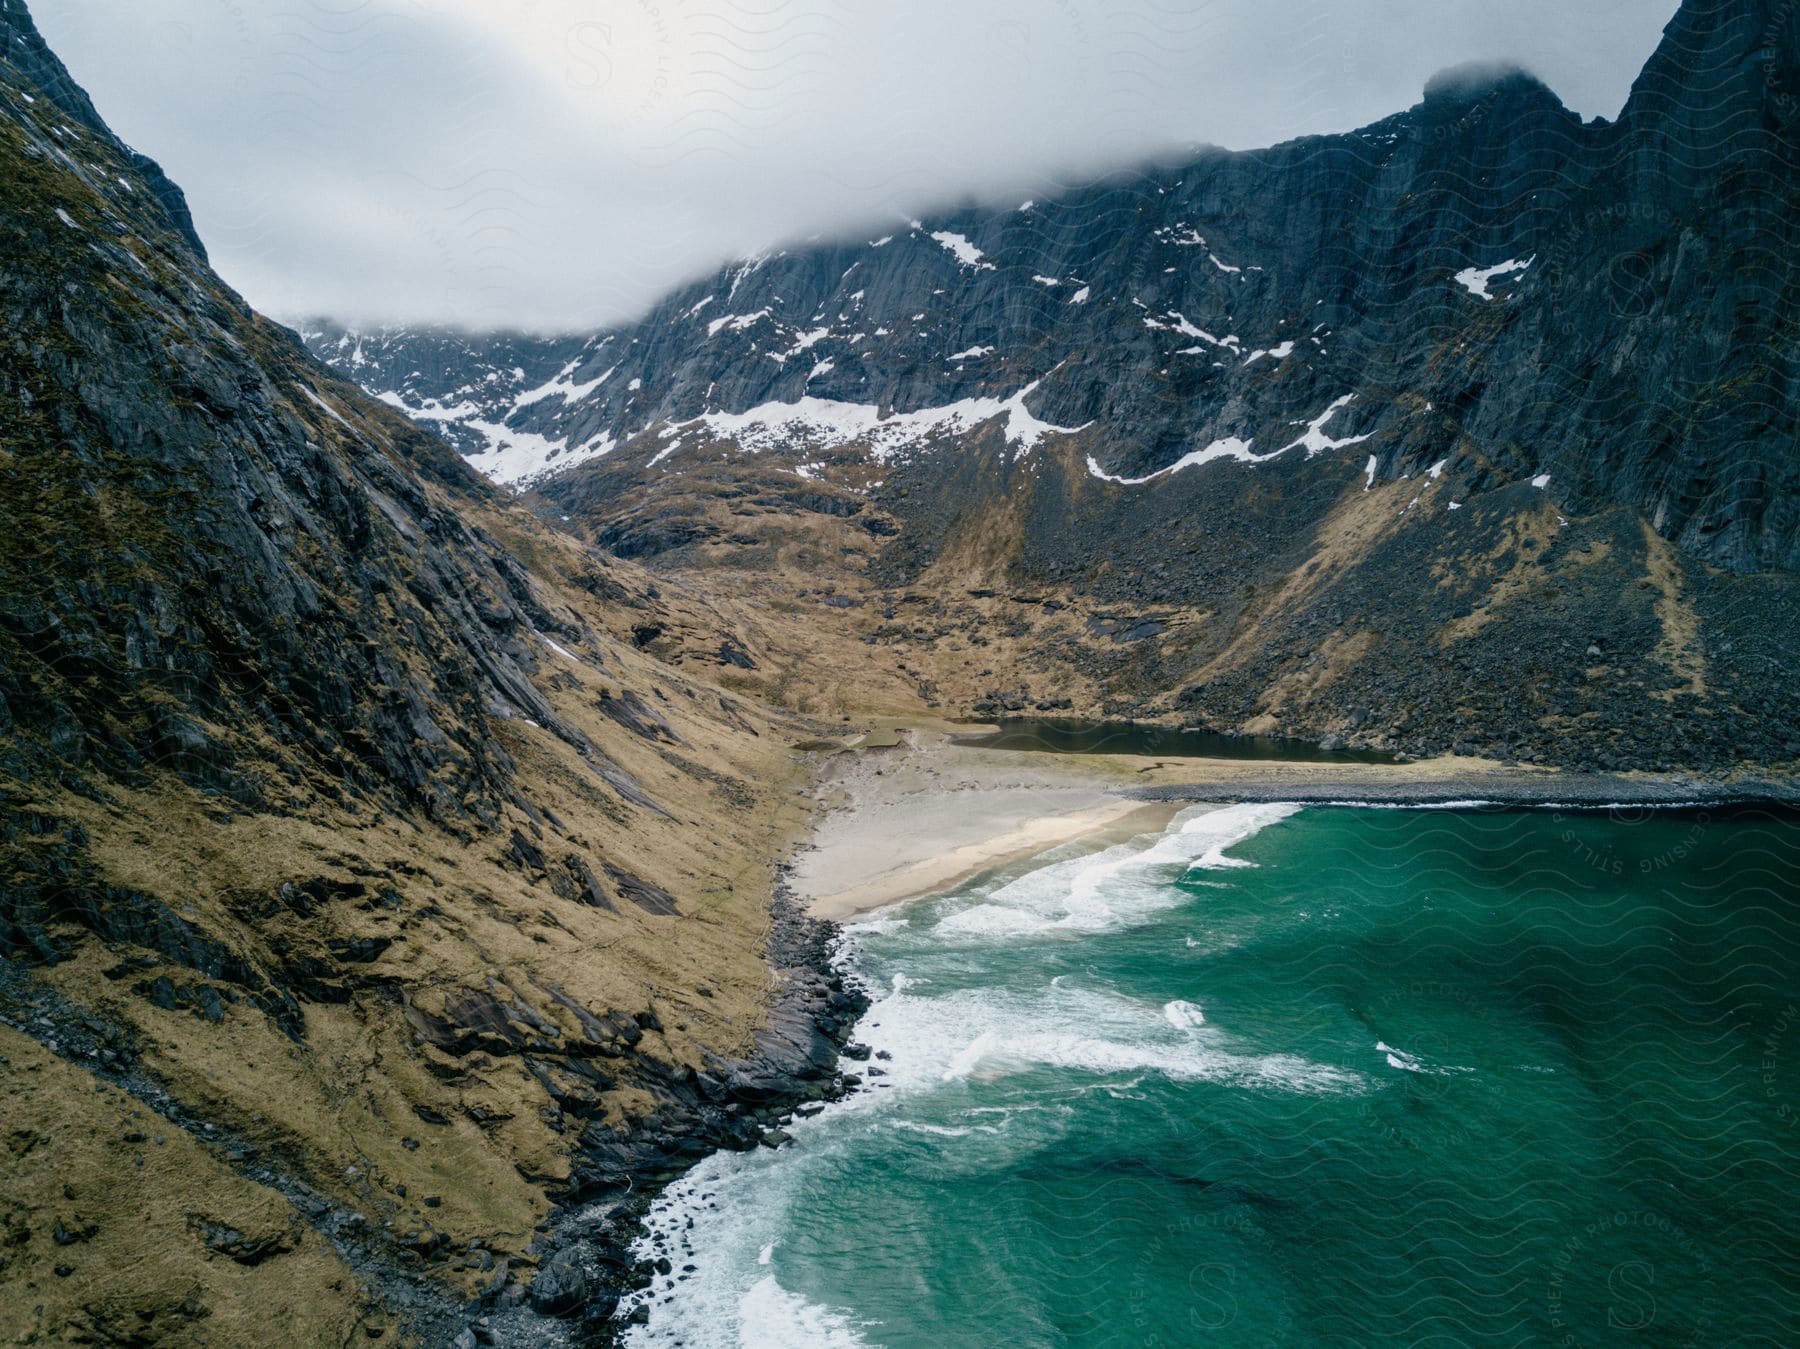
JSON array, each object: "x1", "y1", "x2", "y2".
[{"x1": 0, "y1": 0, "x2": 622, "y2": 821}]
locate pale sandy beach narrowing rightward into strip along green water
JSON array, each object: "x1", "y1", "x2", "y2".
[{"x1": 790, "y1": 722, "x2": 1780, "y2": 919}]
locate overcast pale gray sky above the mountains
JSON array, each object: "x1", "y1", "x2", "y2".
[{"x1": 31, "y1": 0, "x2": 1676, "y2": 330}]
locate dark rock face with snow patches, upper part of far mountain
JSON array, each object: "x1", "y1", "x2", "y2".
[{"x1": 313, "y1": 0, "x2": 1800, "y2": 571}]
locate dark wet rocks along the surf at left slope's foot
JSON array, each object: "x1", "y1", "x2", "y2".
[{"x1": 475, "y1": 879, "x2": 869, "y2": 1349}]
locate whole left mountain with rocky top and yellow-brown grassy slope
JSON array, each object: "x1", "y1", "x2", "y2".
[{"x1": 0, "y1": 0, "x2": 851, "y2": 1344}]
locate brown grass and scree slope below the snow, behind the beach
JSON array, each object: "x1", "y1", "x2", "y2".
[{"x1": 527, "y1": 407, "x2": 1800, "y2": 774}]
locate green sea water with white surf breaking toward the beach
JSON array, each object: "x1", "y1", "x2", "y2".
[{"x1": 632, "y1": 805, "x2": 1800, "y2": 1349}]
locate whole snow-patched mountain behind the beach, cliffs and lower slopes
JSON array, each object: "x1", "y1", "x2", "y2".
[{"x1": 313, "y1": 0, "x2": 1800, "y2": 769}]
